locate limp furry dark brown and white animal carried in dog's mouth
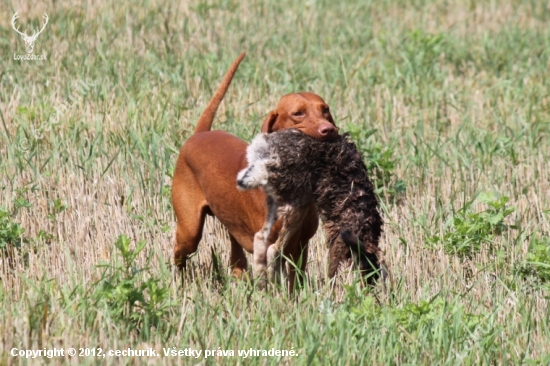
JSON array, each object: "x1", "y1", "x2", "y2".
[{"x1": 237, "y1": 129, "x2": 387, "y2": 282}]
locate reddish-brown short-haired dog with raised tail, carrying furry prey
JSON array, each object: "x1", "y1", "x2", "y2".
[{"x1": 172, "y1": 53, "x2": 338, "y2": 291}]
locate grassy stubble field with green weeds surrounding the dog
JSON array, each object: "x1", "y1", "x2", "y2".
[{"x1": 0, "y1": 0, "x2": 550, "y2": 365}]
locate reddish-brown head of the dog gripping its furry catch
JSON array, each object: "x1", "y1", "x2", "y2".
[{"x1": 262, "y1": 93, "x2": 338, "y2": 141}]
